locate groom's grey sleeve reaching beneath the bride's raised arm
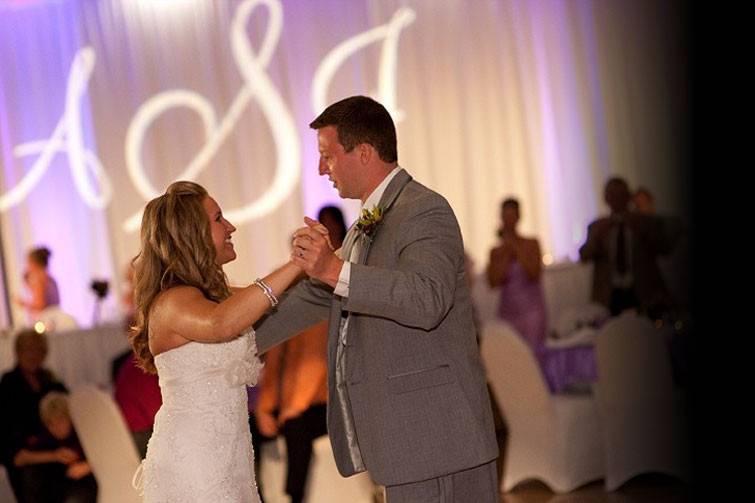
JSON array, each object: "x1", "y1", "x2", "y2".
[{"x1": 254, "y1": 279, "x2": 333, "y2": 354}]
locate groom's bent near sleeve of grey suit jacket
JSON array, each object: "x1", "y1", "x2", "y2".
[{"x1": 344, "y1": 196, "x2": 464, "y2": 330}]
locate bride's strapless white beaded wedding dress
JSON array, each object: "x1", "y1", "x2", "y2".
[{"x1": 134, "y1": 329, "x2": 262, "y2": 503}]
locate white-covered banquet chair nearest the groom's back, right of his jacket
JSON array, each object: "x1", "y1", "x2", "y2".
[{"x1": 481, "y1": 322, "x2": 603, "y2": 493}]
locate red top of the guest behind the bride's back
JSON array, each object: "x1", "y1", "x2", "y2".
[{"x1": 114, "y1": 352, "x2": 163, "y2": 458}]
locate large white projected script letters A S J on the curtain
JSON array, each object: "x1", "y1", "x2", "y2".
[{"x1": 0, "y1": 0, "x2": 415, "y2": 232}]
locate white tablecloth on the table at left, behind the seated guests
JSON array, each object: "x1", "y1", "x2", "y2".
[{"x1": 0, "y1": 322, "x2": 129, "y2": 389}]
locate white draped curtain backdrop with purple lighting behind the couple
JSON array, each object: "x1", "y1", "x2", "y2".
[{"x1": 0, "y1": 0, "x2": 688, "y2": 325}]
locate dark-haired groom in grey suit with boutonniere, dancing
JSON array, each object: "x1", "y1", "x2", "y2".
[{"x1": 256, "y1": 96, "x2": 500, "y2": 503}]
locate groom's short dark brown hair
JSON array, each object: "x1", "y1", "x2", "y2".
[{"x1": 309, "y1": 96, "x2": 398, "y2": 162}]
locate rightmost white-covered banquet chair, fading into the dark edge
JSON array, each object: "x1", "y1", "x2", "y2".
[{"x1": 593, "y1": 313, "x2": 690, "y2": 491}]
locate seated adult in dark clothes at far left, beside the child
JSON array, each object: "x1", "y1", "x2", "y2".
[{"x1": 0, "y1": 330, "x2": 66, "y2": 502}]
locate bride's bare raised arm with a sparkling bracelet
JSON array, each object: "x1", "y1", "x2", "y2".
[{"x1": 150, "y1": 262, "x2": 301, "y2": 342}]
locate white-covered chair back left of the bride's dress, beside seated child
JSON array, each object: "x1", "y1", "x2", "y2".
[{"x1": 69, "y1": 385, "x2": 141, "y2": 503}]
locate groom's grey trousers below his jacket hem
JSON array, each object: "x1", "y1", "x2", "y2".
[{"x1": 385, "y1": 460, "x2": 501, "y2": 503}]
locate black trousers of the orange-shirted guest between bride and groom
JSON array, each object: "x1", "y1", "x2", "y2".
[{"x1": 282, "y1": 404, "x2": 328, "y2": 503}]
